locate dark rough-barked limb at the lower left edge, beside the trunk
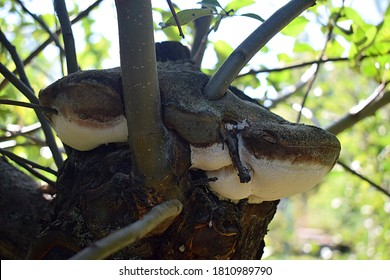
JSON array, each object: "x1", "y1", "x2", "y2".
[{"x1": 0, "y1": 157, "x2": 51, "y2": 259}]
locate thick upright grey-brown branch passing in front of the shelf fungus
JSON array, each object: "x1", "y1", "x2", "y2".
[{"x1": 115, "y1": 0, "x2": 170, "y2": 185}]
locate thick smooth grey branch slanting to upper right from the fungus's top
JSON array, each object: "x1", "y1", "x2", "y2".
[{"x1": 203, "y1": 0, "x2": 316, "y2": 100}]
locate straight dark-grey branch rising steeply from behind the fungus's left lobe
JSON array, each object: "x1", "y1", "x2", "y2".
[{"x1": 54, "y1": 0, "x2": 79, "y2": 74}]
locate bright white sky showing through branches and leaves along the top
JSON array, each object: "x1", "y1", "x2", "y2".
[{"x1": 20, "y1": 0, "x2": 390, "y2": 95}]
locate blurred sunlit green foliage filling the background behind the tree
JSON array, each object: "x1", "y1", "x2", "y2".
[{"x1": 0, "y1": 0, "x2": 390, "y2": 259}]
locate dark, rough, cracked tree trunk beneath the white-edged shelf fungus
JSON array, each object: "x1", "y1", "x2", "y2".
[{"x1": 33, "y1": 144, "x2": 278, "y2": 259}]
